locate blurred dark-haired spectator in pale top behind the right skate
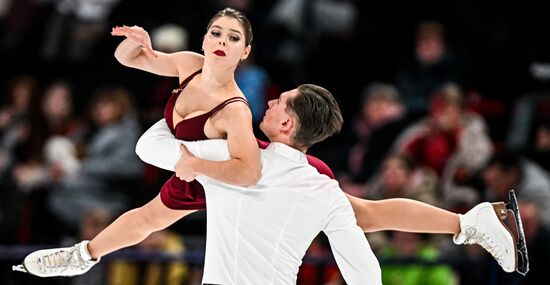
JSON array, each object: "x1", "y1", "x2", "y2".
[{"x1": 483, "y1": 151, "x2": 550, "y2": 227}]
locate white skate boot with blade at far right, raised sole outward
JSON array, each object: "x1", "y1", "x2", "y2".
[{"x1": 453, "y1": 191, "x2": 529, "y2": 275}]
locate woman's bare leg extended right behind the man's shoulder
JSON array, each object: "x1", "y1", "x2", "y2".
[{"x1": 346, "y1": 194, "x2": 460, "y2": 234}]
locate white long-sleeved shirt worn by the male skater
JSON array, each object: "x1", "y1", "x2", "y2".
[{"x1": 136, "y1": 120, "x2": 381, "y2": 285}]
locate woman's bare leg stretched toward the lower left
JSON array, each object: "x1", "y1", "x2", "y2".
[{"x1": 88, "y1": 194, "x2": 196, "y2": 259}]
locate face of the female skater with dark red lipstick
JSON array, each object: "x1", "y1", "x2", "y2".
[{"x1": 202, "y1": 17, "x2": 251, "y2": 67}]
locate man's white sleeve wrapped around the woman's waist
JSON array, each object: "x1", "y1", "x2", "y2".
[{"x1": 136, "y1": 119, "x2": 231, "y2": 171}]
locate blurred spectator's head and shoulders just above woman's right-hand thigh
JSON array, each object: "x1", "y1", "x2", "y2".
[{"x1": 366, "y1": 154, "x2": 439, "y2": 205}]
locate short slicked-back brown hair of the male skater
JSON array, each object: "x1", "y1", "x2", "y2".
[{"x1": 286, "y1": 84, "x2": 344, "y2": 148}]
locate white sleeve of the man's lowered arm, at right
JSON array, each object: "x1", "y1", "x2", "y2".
[{"x1": 323, "y1": 189, "x2": 382, "y2": 285}]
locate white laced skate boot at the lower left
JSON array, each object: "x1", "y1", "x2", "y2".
[{"x1": 12, "y1": 241, "x2": 99, "y2": 277}]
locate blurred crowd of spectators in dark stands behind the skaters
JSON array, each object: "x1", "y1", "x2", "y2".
[{"x1": 0, "y1": 0, "x2": 550, "y2": 285}]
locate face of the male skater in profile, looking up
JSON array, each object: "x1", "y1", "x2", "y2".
[{"x1": 260, "y1": 89, "x2": 300, "y2": 139}]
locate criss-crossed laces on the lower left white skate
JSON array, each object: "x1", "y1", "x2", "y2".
[{"x1": 37, "y1": 245, "x2": 88, "y2": 273}]
